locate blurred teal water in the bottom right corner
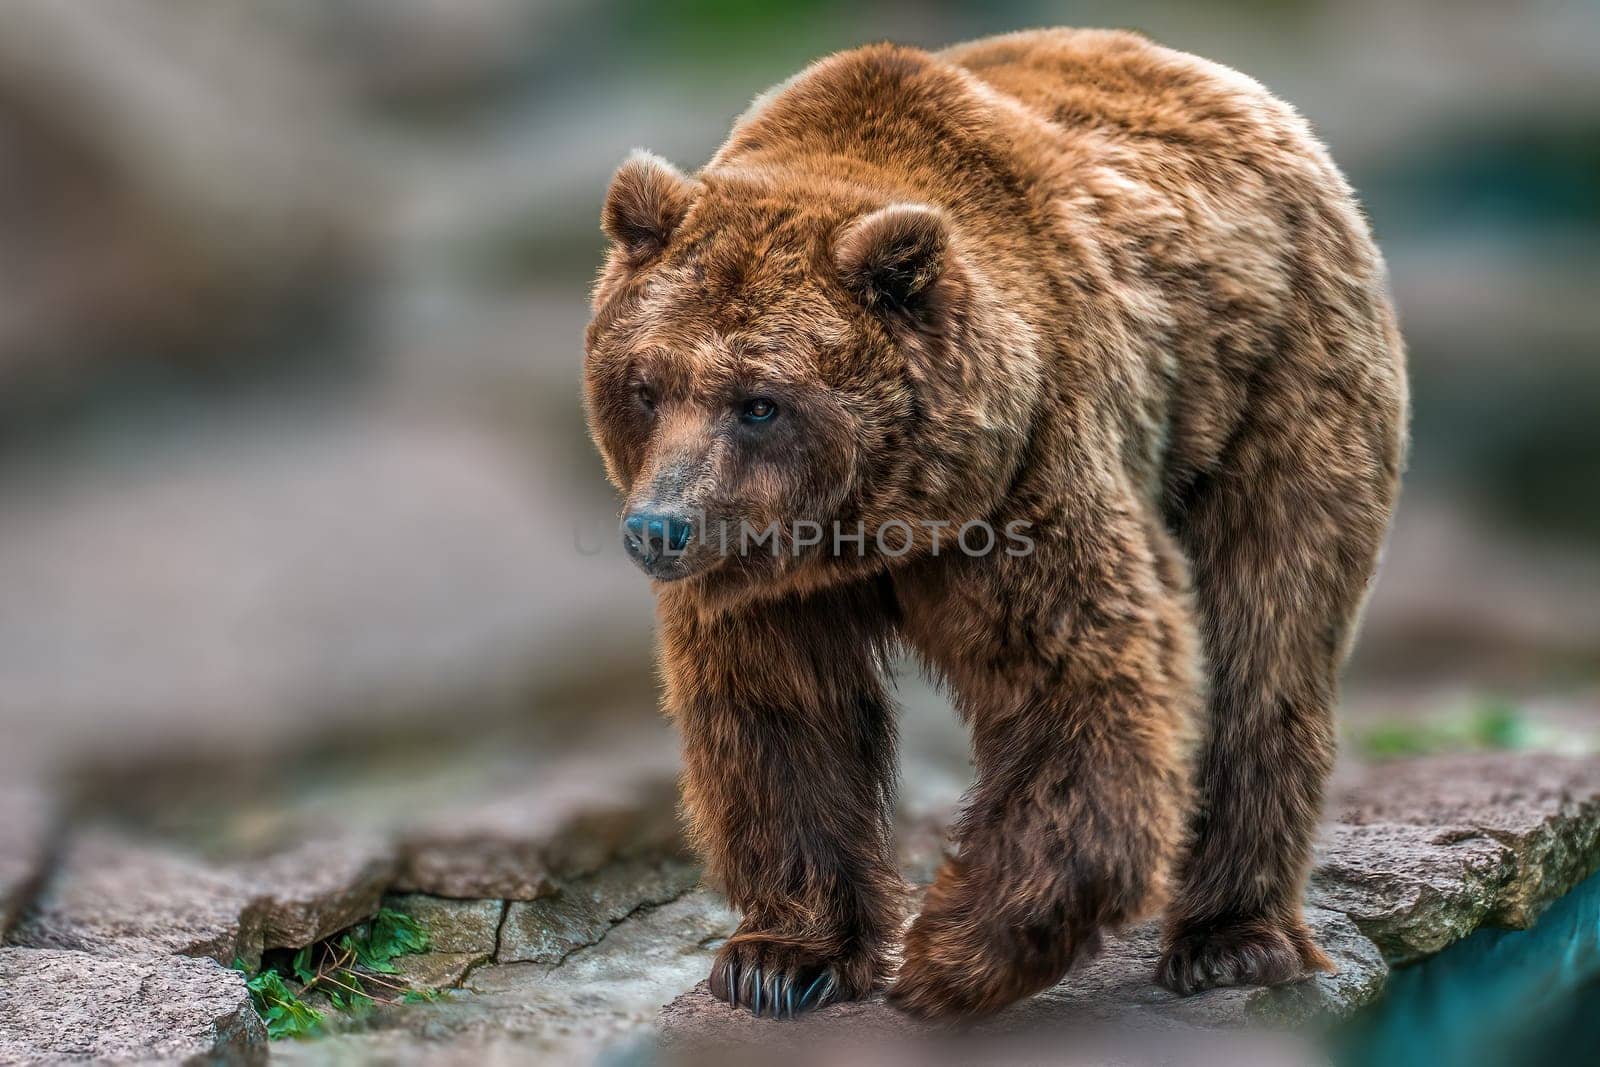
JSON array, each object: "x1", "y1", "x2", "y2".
[{"x1": 1334, "y1": 875, "x2": 1600, "y2": 1067}]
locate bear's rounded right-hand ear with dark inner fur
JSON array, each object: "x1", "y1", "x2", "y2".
[{"x1": 834, "y1": 203, "x2": 950, "y2": 310}]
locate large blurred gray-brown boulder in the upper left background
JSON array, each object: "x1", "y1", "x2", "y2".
[{"x1": 0, "y1": 0, "x2": 371, "y2": 403}]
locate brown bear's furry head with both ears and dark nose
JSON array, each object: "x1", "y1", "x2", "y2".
[{"x1": 584, "y1": 154, "x2": 1040, "y2": 597}]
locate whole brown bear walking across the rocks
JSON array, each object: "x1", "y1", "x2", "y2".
[{"x1": 586, "y1": 30, "x2": 1406, "y2": 1017}]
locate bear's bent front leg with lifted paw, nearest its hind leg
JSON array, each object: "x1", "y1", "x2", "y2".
[{"x1": 890, "y1": 507, "x2": 1200, "y2": 1017}]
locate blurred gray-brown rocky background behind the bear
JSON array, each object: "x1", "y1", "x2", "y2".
[{"x1": 0, "y1": 0, "x2": 1600, "y2": 1062}]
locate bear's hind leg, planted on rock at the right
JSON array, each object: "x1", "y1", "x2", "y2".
[{"x1": 1157, "y1": 340, "x2": 1400, "y2": 993}]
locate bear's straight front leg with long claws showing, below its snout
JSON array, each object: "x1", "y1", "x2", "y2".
[{"x1": 661, "y1": 587, "x2": 904, "y2": 1017}]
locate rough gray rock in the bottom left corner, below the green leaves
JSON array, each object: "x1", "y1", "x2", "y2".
[{"x1": 0, "y1": 949, "x2": 267, "y2": 1064}]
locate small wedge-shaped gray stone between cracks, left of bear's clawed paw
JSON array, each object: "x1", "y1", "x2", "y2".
[{"x1": 494, "y1": 859, "x2": 699, "y2": 963}]
